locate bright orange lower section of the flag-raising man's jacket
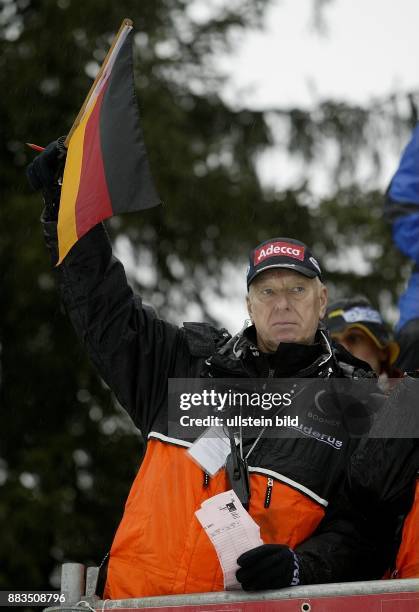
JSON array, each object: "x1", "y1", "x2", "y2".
[{"x1": 104, "y1": 433, "x2": 327, "y2": 599}]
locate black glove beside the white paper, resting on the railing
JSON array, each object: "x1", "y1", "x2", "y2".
[{"x1": 236, "y1": 544, "x2": 302, "y2": 591}]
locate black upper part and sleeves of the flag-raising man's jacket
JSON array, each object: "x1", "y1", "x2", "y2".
[{"x1": 40, "y1": 222, "x2": 410, "y2": 583}]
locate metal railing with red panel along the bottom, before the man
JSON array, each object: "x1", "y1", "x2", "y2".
[{"x1": 47, "y1": 563, "x2": 419, "y2": 612}]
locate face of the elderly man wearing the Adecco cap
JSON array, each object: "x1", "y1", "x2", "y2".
[{"x1": 247, "y1": 268, "x2": 327, "y2": 353}]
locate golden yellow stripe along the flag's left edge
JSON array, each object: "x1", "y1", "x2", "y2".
[{"x1": 57, "y1": 99, "x2": 95, "y2": 266}]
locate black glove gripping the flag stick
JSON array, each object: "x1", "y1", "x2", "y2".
[{"x1": 26, "y1": 136, "x2": 67, "y2": 218}]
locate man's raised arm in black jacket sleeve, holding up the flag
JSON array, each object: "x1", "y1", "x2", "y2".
[{"x1": 28, "y1": 143, "x2": 184, "y2": 435}]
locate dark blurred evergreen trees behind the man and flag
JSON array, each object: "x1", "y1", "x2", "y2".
[{"x1": 0, "y1": 0, "x2": 419, "y2": 589}]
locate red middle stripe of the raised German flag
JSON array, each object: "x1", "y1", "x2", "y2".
[{"x1": 75, "y1": 81, "x2": 113, "y2": 238}]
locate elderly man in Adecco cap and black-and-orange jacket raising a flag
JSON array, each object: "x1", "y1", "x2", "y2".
[{"x1": 29, "y1": 141, "x2": 380, "y2": 599}]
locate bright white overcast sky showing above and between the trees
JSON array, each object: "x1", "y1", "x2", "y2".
[{"x1": 121, "y1": 0, "x2": 419, "y2": 332}]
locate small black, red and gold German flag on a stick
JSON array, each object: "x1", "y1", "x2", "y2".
[{"x1": 57, "y1": 20, "x2": 160, "y2": 265}]
